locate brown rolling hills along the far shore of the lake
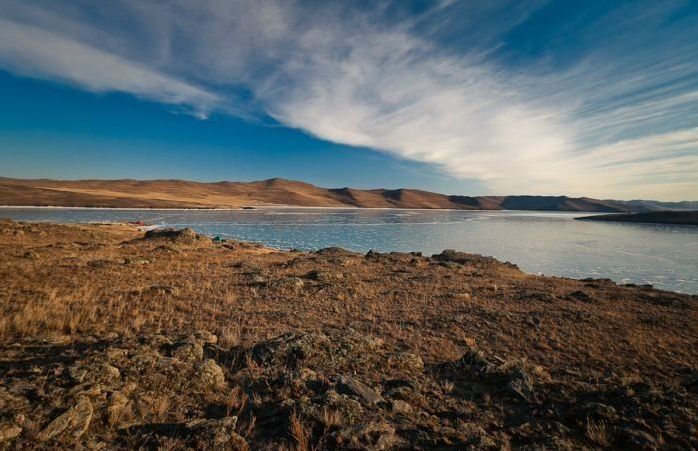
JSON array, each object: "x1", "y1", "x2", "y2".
[{"x1": 0, "y1": 177, "x2": 698, "y2": 213}]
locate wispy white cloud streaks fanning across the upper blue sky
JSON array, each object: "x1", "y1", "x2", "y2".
[{"x1": 0, "y1": 0, "x2": 698, "y2": 199}]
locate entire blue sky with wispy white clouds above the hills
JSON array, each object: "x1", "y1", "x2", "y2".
[{"x1": 0, "y1": 0, "x2": 698, "y2": 200}]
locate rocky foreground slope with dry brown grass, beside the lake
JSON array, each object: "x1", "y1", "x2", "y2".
[{"x1": 0, "y1": 221, "x2": 698, "y2": 449}]
